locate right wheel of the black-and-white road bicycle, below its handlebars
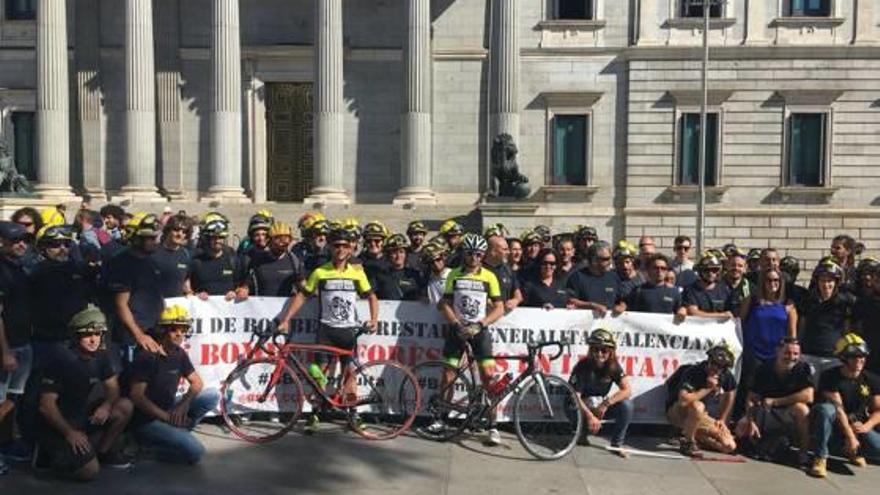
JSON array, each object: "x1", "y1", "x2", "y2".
[{"x1": 513, "y1": 374, "x2": 583, "y2": 460}]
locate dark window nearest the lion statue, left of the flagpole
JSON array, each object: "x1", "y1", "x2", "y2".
[{"x1": 551, "y1": 115, "x2": 589, "y2": 186}]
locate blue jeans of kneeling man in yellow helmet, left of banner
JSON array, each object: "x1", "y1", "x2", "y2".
[{"x1": 134, "y1": 389, "x2": 220, "y2": 464}]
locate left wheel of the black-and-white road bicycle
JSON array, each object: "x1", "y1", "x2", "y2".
[{"x1": 413, "y1": 361, "x2": 476, "y2": 442}]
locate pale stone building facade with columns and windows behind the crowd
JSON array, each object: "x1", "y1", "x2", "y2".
[{"x1": 0, "y1": 0, "x2": 880, "y2": 259}]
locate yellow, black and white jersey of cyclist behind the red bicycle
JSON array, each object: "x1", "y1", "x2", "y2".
[{"x1": 303, "y1": 263, "x2": 373, "y2": 328}]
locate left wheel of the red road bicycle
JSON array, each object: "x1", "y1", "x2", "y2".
[{"x1": 220, "y1": 358, "x2": 303, "y2": 443}]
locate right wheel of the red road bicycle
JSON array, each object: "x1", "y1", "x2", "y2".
[{"x1": 346, "y1": 361, "x2": 421, "y2": 440}]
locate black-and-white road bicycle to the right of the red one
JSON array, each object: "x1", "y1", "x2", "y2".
[{"x1": 413, "y1": 340, "x2": 584, "y2": 460}]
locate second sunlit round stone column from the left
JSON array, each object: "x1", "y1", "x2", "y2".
[{"x1": 121, "y1": 0, "x2": 161, "y2": 201}]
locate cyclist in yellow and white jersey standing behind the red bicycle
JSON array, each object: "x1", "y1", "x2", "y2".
[{"x1": 277, "y1": 228, "x2": 379, "y2": 431}]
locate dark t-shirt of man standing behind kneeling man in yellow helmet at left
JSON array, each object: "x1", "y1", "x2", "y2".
[{"x1": 106, "y1": 249, "x2": 165, "y2": 345}]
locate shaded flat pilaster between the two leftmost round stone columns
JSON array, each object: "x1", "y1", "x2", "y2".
[{"x1": 75, "y1": 0, "x2": 106, "y2": 199}]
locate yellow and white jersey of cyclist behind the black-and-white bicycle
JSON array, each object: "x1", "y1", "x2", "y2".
[{"x1": 443, "y1": 267, "x2": 501, "y2": 323}]
